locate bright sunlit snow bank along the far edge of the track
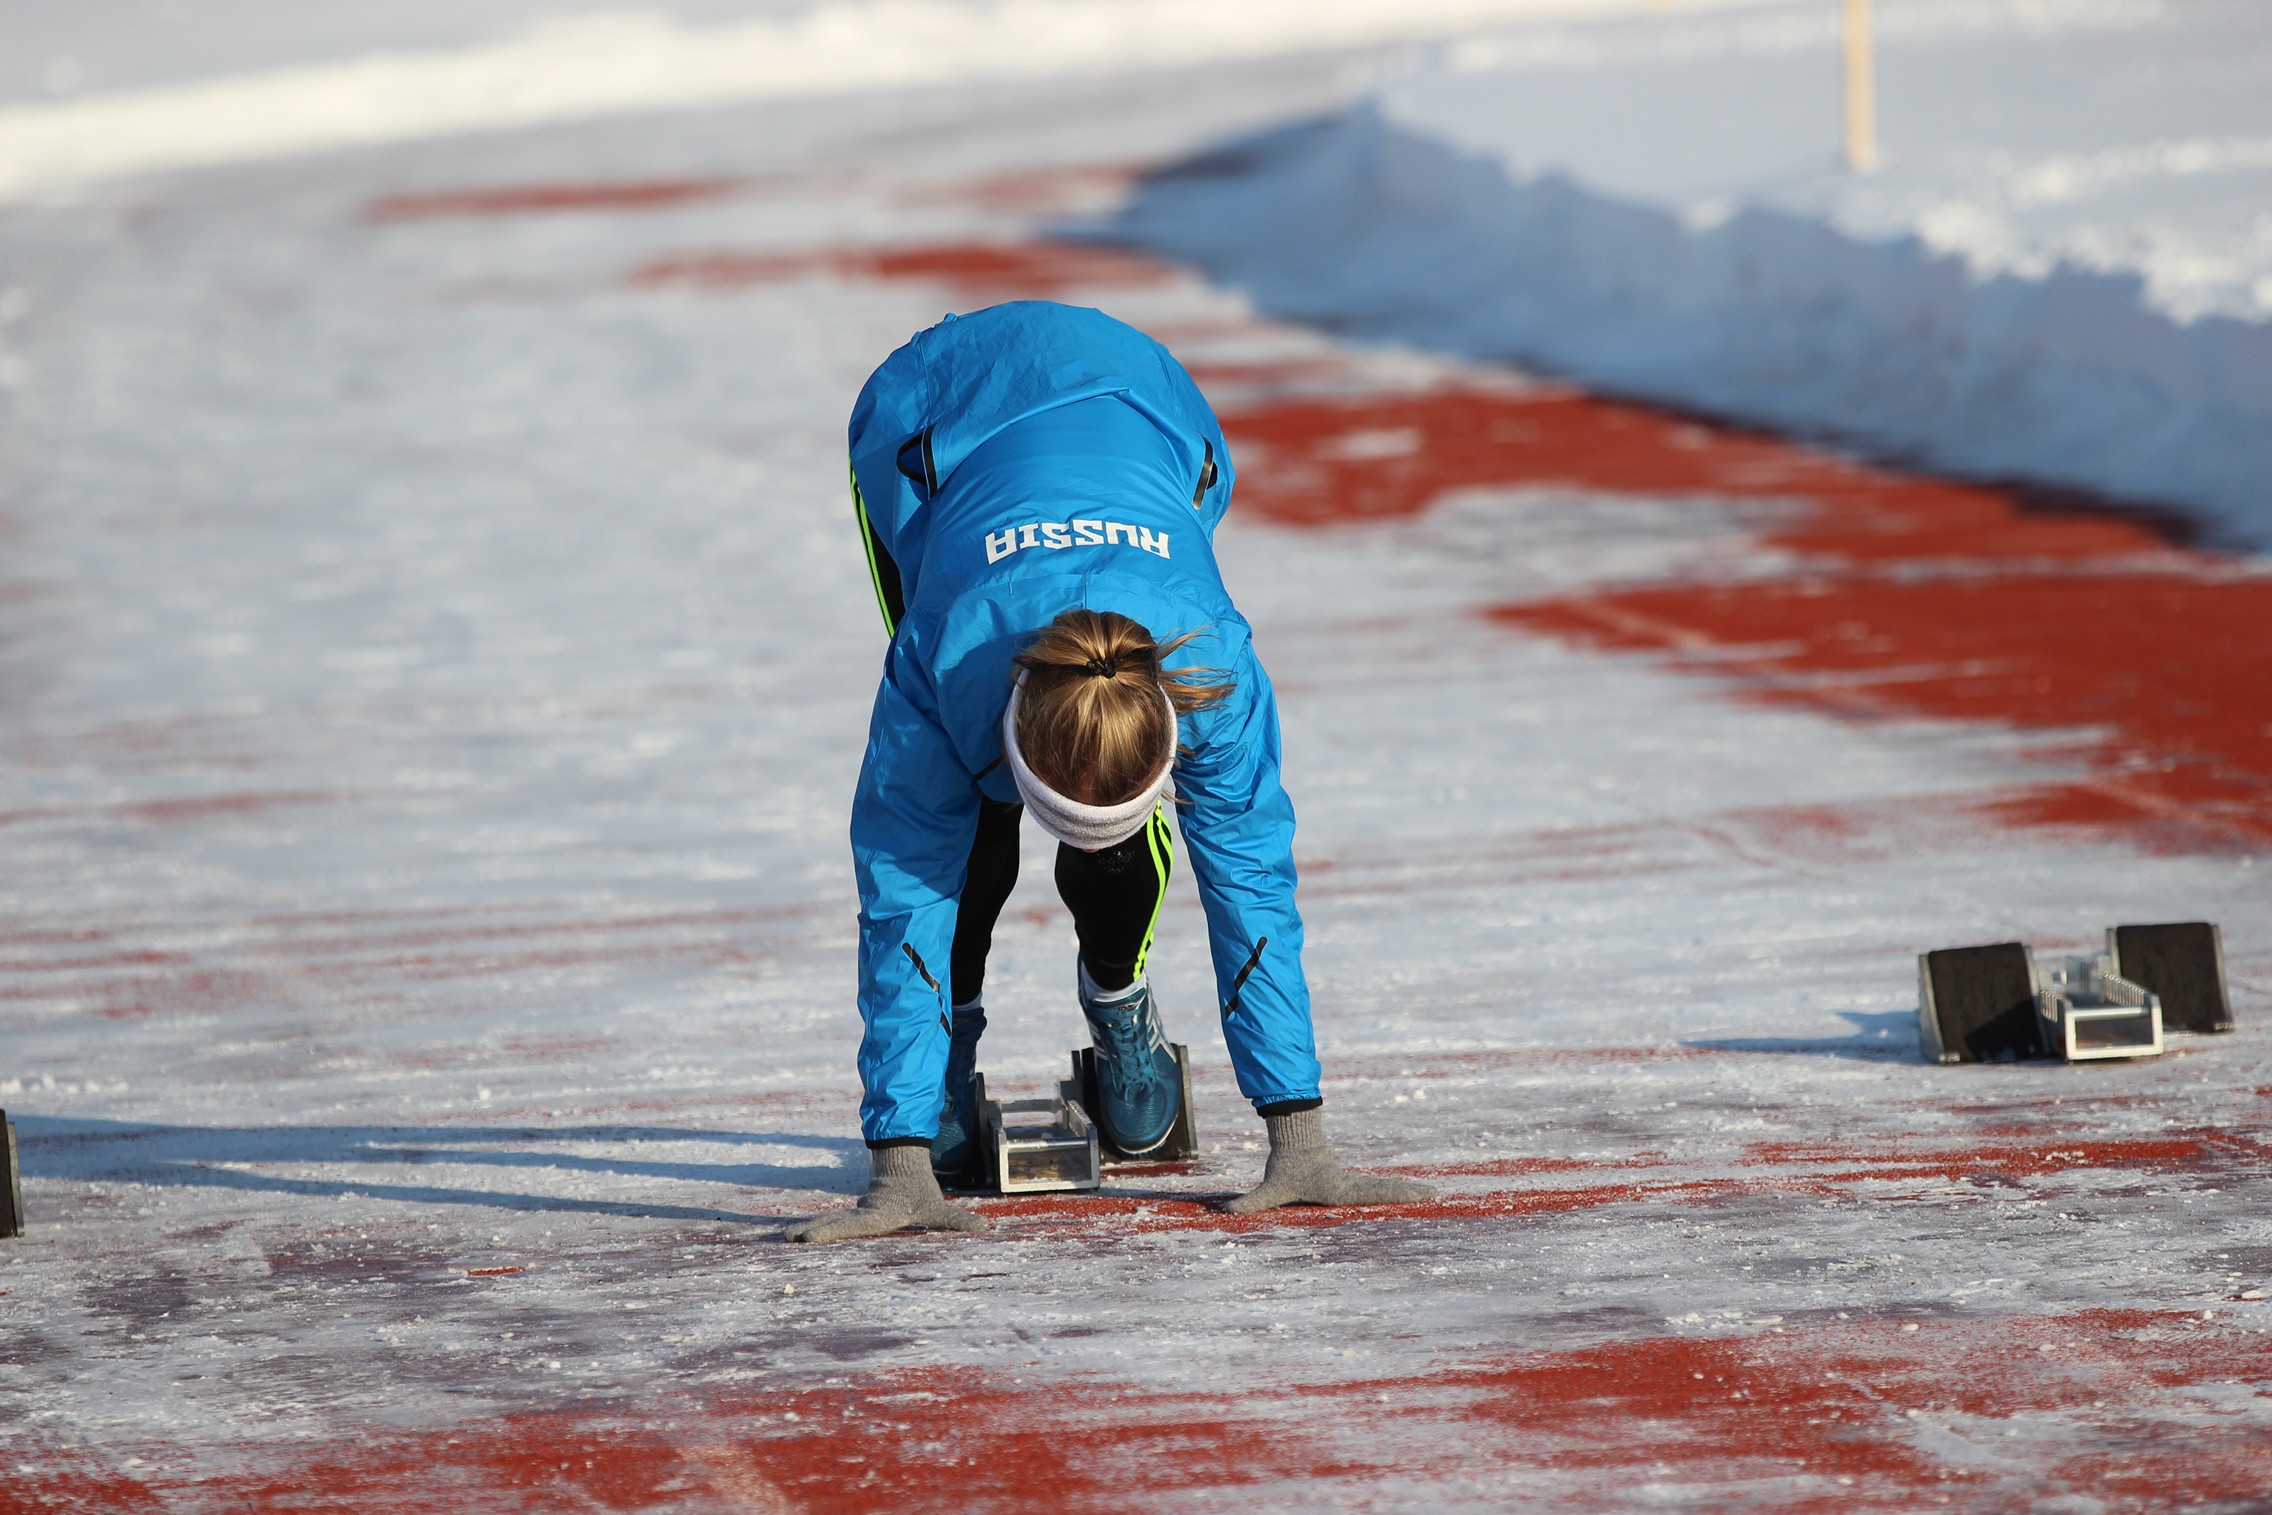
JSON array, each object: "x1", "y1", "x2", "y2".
[{"x1": 0, "y1": 0, "x2": 1747, "y2": 200}]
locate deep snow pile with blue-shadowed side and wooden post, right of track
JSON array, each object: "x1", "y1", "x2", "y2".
[{"x1": 1118, "y1": 0, "x2": 2272, "y2": 545}]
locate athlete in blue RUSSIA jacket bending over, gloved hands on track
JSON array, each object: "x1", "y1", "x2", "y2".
[{"x1": 788, "y1": 302, "x2": 1434, "y2": 1242}]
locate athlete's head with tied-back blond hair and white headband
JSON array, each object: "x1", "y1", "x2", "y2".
[{"x1": 1011, "y1": 611, "x2": 1229, "y2": 806}]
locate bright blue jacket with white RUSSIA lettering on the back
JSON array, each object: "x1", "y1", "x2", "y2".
[{"x1": 852, "y1": 302, "x2": 1318, "y2": 1142}]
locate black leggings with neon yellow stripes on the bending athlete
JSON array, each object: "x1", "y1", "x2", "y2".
[{"x1": 852, "y1": 508, "x2": 1175, "y2": 1004}]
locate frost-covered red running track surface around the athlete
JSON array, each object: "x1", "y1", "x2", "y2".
[{"x1": 0, "y1": 23, "x2": 2272, "y2": 1510}]
